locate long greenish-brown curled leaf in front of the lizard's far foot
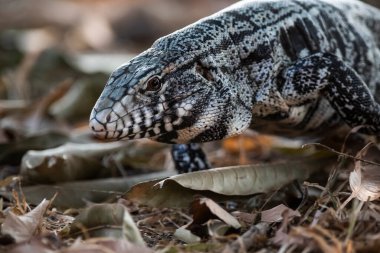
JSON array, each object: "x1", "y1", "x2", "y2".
[{"x1": 126, "y1": 157, "x2": 331, "y2": 207}]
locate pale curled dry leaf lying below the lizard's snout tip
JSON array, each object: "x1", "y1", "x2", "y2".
[{"x1": 21, "y1": 142, "x2": 126, "y2": 183}]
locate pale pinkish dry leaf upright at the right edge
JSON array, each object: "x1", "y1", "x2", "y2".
[{"x1": 346, "y1": 145, "x2": 380, "y2": 202}]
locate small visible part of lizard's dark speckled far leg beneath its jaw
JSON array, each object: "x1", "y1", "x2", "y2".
[{"x1": 171, "y1": 143, "x2": 210, "y2": 173}]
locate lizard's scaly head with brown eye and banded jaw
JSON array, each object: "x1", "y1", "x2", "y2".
[{"x1": 90, "y1": 48, "x2": 251, "y2": 143}]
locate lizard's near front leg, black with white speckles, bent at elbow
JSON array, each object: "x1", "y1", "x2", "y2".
[{"x1": 278, "y1": 53, "x2": 380, "y2": 135}]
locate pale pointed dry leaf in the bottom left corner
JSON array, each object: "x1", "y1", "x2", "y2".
[{"x1": 1, "y1": 199, "x2": 49, "y2": 242}]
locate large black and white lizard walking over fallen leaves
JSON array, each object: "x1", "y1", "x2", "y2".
[{"x1": 90, "y1": 0, "x2": 380, "y2": 170}]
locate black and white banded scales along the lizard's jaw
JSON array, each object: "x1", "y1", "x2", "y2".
[{"x1": 90, "y1": 93, "x2": 199, "y2": 142}]
